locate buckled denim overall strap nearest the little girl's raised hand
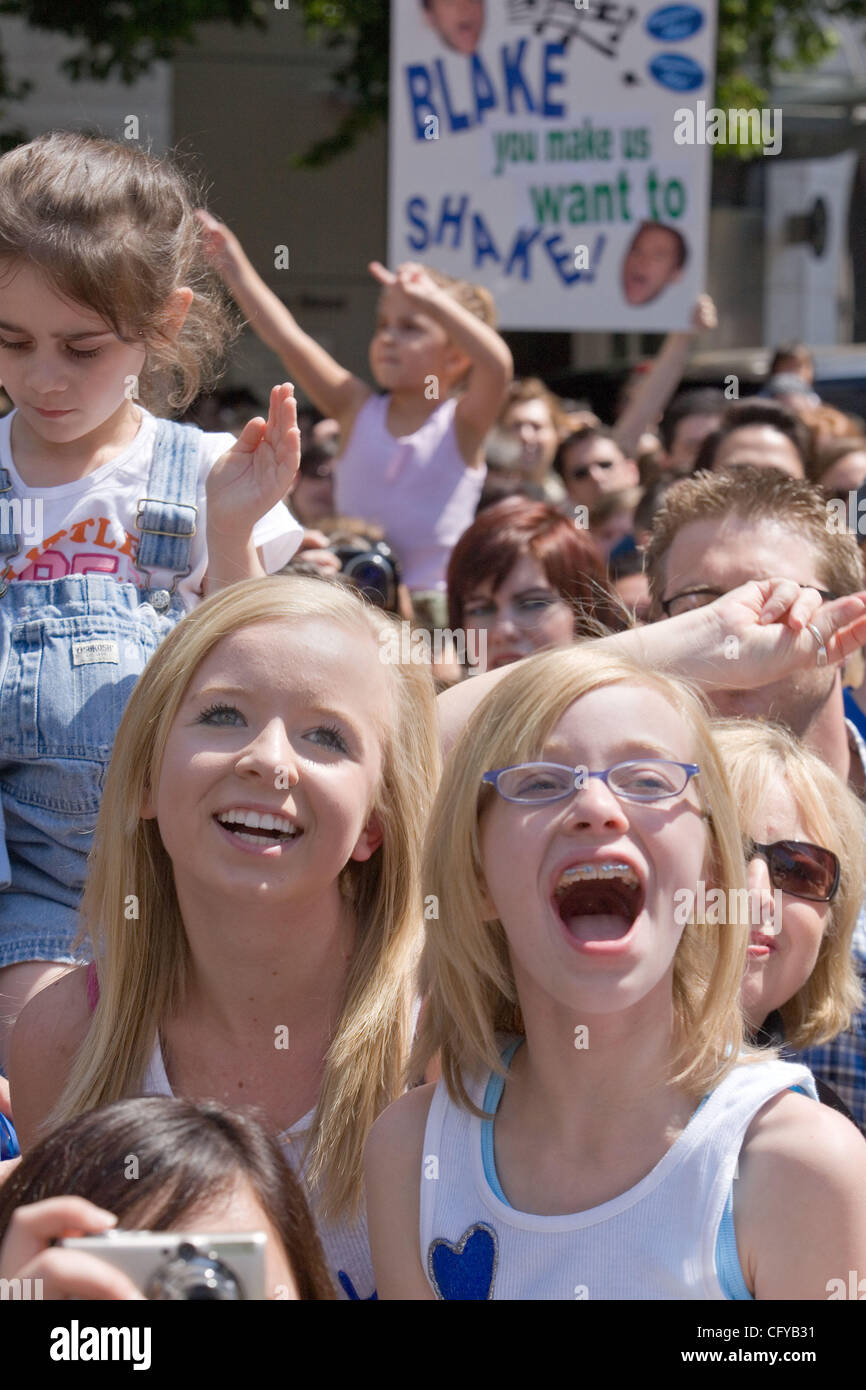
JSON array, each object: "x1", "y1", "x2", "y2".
[{"x1": 135, "y1": 420, "x2": 200, "y2": 607}]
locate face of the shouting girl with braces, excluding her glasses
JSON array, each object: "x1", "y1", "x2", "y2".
[{"x1": 480, "y1": 684, "x2": 708, "y2": 1016}]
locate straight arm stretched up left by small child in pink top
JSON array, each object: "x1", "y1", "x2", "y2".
[{"x1": 196, "y1": 209, "x2": 371, "y2": 425}]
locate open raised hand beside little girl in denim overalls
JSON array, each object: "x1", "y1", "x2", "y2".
[{"x1": 207, "y1": 382, "x2": 300, "y2": 538}]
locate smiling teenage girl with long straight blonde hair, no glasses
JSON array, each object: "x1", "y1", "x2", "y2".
[{"x1": 11, "y1": 577, "x2": 438, "y2": 1298}]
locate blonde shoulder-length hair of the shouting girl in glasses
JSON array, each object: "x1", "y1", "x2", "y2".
[{"x1": 411, "y1": 646, "x2": 767, "y2": 1113}]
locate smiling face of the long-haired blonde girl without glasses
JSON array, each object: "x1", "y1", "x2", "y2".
[{"x1": 143, "y1": 619, "x2": 392, "y2": 910}]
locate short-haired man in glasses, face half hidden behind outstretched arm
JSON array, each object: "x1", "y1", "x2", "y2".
[{"x1": 646, "y1": 466, "x2": 866, "y2": 1126}]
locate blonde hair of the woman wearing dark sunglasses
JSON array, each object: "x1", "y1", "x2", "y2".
[{"x1": 713, "y1": 719, "x2": 866, "y2": 1049}]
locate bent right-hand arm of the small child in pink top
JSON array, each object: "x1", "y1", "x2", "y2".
[{"x1": 370, "y1": 261, "x2": 514, "y2": 463}]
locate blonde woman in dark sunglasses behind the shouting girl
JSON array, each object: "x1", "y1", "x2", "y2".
[{"x1": 713, "y1": 719, "x2": 866, "y2": 1115}]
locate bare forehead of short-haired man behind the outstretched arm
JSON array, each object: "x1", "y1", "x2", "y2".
[{"x1": 664, "y1": 516, "x2": 823, "y2": 594}]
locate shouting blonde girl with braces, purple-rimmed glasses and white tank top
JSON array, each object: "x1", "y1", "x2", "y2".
[{"x1": 367, "y1": 648, "x2": 866, "y2": 1301}]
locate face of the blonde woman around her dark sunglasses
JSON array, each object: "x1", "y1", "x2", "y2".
[{"x1": 742, "y1": 776, "x2": 833, "y2": 1027}]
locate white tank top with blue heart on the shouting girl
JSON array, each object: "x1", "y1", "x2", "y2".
[{"x1": 420, "y1": 1061, "x2": 815, "y2": 1300}]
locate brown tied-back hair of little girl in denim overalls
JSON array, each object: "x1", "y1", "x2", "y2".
[{"x1": 0, "y1": 131, "x2": 238, "y2": 411}]
